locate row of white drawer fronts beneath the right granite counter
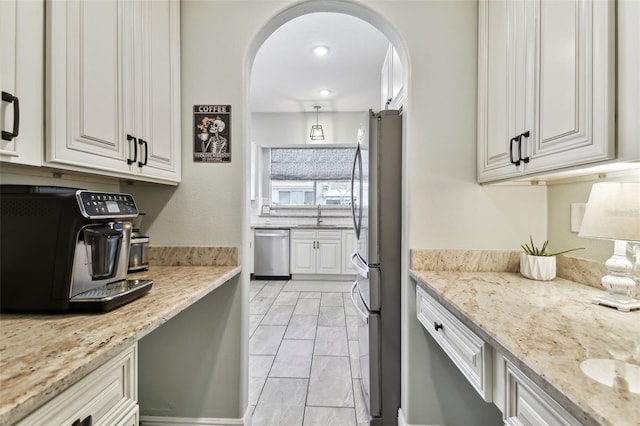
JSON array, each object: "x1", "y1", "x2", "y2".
[{"x1": 416, "y1": 286, "x2": 581, "y2": 426}]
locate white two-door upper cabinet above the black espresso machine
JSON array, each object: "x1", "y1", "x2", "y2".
[{"x1": 46, "y1": 0, "x2": 180, "y2": 182}]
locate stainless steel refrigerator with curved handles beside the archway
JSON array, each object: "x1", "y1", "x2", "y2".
[{"x1": 351, "y1": 110, "x2": 402, "y2": 426}]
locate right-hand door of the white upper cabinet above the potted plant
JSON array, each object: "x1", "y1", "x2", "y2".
[{"x1": 531, "y1": 0, "x2": 615, "y2": 169}]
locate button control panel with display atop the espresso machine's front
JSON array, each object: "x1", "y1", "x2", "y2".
[{"x1": 76, "y1": 190, "x2": 138, "y2": 219}]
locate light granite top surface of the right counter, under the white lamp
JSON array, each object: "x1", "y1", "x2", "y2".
[{"x1": 410, "y1": 270, "x2": 640, "y2": 426}]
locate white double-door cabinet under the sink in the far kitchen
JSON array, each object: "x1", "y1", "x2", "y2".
[{"x1": 291, "y1": 229, "x2": 342, "y2": 275}]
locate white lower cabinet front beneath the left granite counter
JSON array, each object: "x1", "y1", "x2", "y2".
[{"x1": 17, "y1": 343, "x2": 139, "y2": 426}]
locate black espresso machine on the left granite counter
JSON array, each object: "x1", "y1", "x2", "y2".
[{"x1": 0, "y1": 185, "x2": 153, "y2": 313}]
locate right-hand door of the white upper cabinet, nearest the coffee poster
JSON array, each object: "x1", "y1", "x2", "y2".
[{"x1": 132, "y1": 0, "x2": 180, "y2": 181}]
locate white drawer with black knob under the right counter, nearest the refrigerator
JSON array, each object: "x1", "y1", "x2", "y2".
[{"x1": 416, "y1": 286, "x2": 493, "y2": 402}]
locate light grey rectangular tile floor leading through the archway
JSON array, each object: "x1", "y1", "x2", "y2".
[{"x1": 249, "y1": 281, "x2": 368, "y2": 426}]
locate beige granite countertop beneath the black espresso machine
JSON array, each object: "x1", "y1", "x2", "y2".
[{"x1": 0, "y1": 266, "x2": 241, "y2": 425}]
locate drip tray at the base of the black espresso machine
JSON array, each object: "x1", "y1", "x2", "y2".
[{"x1": 69, "y1": 280, "x2": 153, "y2": 312}]
